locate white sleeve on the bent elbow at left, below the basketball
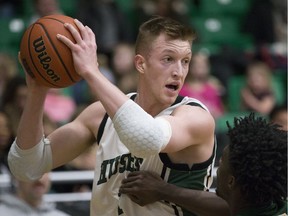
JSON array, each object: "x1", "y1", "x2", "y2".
[{"x1": 8, "y1": 136, "x2": 52, "y2": 181}]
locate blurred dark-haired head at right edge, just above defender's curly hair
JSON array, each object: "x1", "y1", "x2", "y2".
[{"x1": 269, "y1": 102, "x2": 288, "y2": 131}]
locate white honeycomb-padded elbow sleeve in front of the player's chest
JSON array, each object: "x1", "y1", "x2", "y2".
[{"x1": 113, "y1": 100, "x2": 172, "y2": 157}]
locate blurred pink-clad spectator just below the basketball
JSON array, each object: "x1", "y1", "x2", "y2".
[{"x1": 44, "y1": 88, "x2": 76, "y2": 125}]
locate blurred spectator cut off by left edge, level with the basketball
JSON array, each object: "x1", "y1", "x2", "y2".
[{"x1": 0, "y1": 53, "x2": 18, "y2": 105}]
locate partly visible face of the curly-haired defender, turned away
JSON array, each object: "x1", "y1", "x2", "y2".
[{"x1": 216, "y1": 146, "x2": 232, "y2": 201}]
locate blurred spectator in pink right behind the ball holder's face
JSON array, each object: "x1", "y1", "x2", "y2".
[{"x1": 179, "y1": 53, "x2": 224, "y2": 118}]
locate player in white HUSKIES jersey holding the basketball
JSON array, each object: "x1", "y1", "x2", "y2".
[{"x1": 9, "y1": 17, "x2": 226, "y2": 216}]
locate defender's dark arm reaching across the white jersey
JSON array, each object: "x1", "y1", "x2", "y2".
[{"x1": 119, "y1": 171, "x2": 230, "y2": 216}]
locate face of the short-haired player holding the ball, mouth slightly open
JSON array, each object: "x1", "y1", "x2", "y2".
[{"x1": 141, "y1": 34, "x2": 192, "y2": 106}]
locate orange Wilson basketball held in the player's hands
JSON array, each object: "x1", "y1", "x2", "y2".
[{"x1": 20, "y1": 15, "x2": 81, "y2": 88}]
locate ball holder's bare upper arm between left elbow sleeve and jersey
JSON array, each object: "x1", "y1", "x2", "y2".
[{"x1": 48, "y1": 102, "x2": 105, "y2": 168}]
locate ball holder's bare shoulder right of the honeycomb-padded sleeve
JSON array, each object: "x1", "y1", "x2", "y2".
[{"x1": 166, "y1": 105, "x2": 215, "y2": 164}]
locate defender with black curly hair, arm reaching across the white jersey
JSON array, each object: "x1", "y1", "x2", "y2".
[{"x1": 120, "y1": 115, "x2": 287, "y2": 216}]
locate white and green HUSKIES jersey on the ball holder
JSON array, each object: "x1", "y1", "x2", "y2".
[{"x1": 91, "y1": 95, "x2": 216, "y2": 216}]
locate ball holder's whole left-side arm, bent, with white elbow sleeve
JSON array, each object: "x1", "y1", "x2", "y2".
[{"x1": 8, "y1": 63, "x2": 105, "y2": 180}]
